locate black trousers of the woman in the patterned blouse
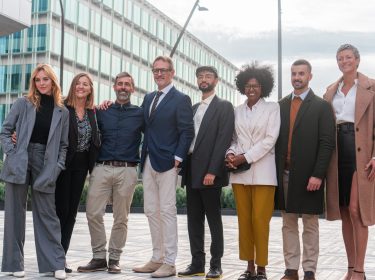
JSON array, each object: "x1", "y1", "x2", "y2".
[{"x1": 55, "y1": 152, "x2": 89, "y2": 254}]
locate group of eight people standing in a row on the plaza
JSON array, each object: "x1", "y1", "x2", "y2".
[{"x1": 0, "y1": 44, "x2": 375, "y2": 280}]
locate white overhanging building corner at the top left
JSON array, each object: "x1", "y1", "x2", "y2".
[{"x1": 0, "y1": 0, "x2": 31, "y2": 36}]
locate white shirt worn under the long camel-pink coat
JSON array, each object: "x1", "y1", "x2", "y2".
[{"x1": 332, "y1": 79, "x2": 358, "y2": 124}]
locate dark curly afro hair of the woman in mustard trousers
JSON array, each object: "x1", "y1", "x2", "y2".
[{"x1": 235, "y1": 61, "x2": 275, "y2": 97}]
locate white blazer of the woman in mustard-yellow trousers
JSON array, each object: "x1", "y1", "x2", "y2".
[{"x1": 227, "y1": 98, "x2": 280, "y2": 186}]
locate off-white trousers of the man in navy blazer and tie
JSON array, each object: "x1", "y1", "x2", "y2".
[{"x1": 143, "y1": 156, "x2": 177, "y2": 265}]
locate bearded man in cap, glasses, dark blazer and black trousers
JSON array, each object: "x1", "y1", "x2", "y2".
[{"x1": 178, "y1": 66, "x2": 234, "y2": 279}]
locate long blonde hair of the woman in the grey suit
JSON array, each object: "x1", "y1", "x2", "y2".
[{"x1": 27, "y1": 63, "x2": 64, "y2": 110}]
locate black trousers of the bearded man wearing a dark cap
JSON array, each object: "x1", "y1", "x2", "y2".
[{"x1": 186, "y1": 184, "x2": 224, "y2": 269}]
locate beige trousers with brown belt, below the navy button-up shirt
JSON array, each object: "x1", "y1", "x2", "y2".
[{"x1": 86, "y1": 165, "x2": 137, "y2": 260}]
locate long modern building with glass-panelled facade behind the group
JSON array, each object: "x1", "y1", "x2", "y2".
[{"x1": 0, "y1": 0, "x2": 238, "y2": 123}]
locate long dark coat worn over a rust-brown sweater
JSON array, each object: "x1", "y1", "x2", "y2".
[{"x1": 275, "y1": 89, "x2": 336, "y2": 215}]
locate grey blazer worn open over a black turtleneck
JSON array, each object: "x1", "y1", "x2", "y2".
[{"x1": 0, "y1": 97, "x2": 69, "y2": 193}]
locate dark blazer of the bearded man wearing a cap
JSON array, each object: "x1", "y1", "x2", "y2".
[{"x1": 181, "y1": 96, "x2": 234, "y2": 189}]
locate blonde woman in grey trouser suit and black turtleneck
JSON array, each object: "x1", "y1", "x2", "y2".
[{"x1": 0, "y1": 64, "x2": 69, "y2": 279}]
